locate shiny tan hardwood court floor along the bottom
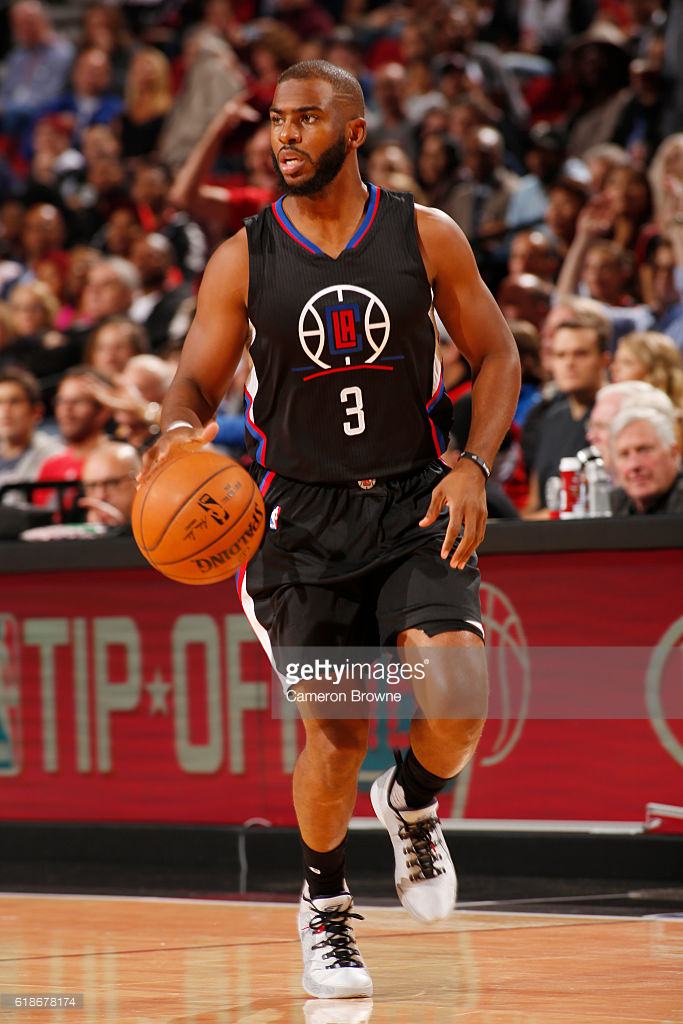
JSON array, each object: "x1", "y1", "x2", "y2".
[{"x1": 0, "y1": 894, "x2": 683, "y2": 1024}]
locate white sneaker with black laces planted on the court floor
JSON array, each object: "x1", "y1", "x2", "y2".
[{"x1": 299, "y1": 885, "x2": 373, "y2": 999}]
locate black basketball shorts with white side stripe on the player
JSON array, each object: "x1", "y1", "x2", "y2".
[{"x1": 237, "y1": 459, "x2": 483, "y2": 662}]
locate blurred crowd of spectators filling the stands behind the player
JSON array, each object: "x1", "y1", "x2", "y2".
[{"x1": 0, "y1": 0, "x2": 683, "y2": 526}]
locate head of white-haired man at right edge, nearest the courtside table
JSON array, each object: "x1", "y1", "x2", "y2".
[{"x1": 610, "y1": 406, "x2": 683, "y2": 515}]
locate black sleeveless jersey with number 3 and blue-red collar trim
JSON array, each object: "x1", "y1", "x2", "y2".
[{"x1": 245, "y1": 184, "x2": 452, "y2": 483}]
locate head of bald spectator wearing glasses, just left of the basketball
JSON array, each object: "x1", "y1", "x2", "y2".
[{"x1": 79, "y1": 441, "x2": 142, "y2": 534}]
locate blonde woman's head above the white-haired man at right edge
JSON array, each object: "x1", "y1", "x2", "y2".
[{"x1": 610, "y1": 331, "x2": 683, "y2": 412}]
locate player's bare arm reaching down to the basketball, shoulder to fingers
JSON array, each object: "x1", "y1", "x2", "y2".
[{"x1": 144, "y1": 229, "x2": 249, "y2": 472}]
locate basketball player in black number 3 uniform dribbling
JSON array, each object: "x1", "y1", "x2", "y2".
[{"x1": 141, "y1": 60, "x2": 519, "y2": 997}]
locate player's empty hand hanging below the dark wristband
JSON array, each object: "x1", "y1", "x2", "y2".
[{"x1": 420, "y1": 459, "x2": 486, "y2": 569}]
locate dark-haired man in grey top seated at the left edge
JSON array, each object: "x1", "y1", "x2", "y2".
[{"x1": 0, "y1": 368, "x2": 62, "y2": 487}]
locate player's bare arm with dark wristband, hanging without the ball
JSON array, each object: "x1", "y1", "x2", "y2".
[{"x1": 417, "y1": 207, "x2": 520, "y2": 568}]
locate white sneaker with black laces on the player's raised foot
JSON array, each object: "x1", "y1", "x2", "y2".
[{"x1": 370, "y1": 768, "x2": 458, "y2": 924}]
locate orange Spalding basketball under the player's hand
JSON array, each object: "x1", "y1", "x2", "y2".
[{"x1": 132, "y1": 452, "x2": 265, "y2": 585}]
